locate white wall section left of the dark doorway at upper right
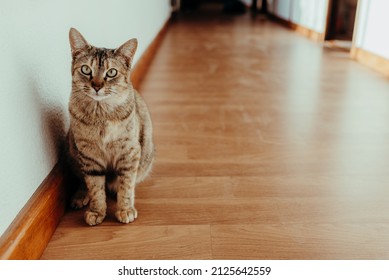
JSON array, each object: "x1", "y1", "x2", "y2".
[{"x1": 268, "y1": 0, "x2": 328, "y2": 33}]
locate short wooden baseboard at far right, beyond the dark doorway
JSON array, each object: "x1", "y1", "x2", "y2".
[{"x1": 351, "y1": 47, "x2": 389, "y2": 77}]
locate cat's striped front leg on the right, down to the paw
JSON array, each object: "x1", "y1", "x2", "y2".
[{"x1": 115, "y1": 148, "x2": 140, "y2": 224}]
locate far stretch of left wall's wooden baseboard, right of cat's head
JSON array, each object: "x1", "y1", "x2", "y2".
[{"x1": 131, "y1": 19, "x2": 170, "y2": 89}]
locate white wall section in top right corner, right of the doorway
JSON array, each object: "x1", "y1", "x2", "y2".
[{"x1": 354, "y1": 0, "x2": 389, "y2": 59}]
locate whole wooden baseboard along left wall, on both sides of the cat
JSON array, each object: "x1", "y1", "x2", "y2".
[{"x1": 0, "y1": 20, "x2": 169, "y2": 260}]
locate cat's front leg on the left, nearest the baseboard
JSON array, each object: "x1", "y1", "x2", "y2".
[{"x1": 84, "y1": 175, "x2": 107, "y2": 226}]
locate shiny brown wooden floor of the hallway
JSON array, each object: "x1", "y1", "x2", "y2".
[{"x1": 42, "y1": 6, "x2": 389, "y2": 259}]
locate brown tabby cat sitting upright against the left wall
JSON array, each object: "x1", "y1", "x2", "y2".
[{"x1": 68, "y1": 28, "x2": 154, "y2": 225}]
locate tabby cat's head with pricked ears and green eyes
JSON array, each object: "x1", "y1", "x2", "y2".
[{"x1": 69, "y1": 28, "x2": 138, "y2": 101}]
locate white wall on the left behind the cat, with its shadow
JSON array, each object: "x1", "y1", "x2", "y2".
[{"x1": 0, "y1": 0, "x2": 170, "y2": 237}]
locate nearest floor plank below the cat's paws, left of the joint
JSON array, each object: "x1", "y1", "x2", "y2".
[{"x1": 43, "y1": 221, "x2": 211, "y2": 260}]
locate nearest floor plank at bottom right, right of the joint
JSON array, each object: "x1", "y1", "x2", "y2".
[{"x1": 211, "y1": 223, "x2": 389, "y2": 260}]
